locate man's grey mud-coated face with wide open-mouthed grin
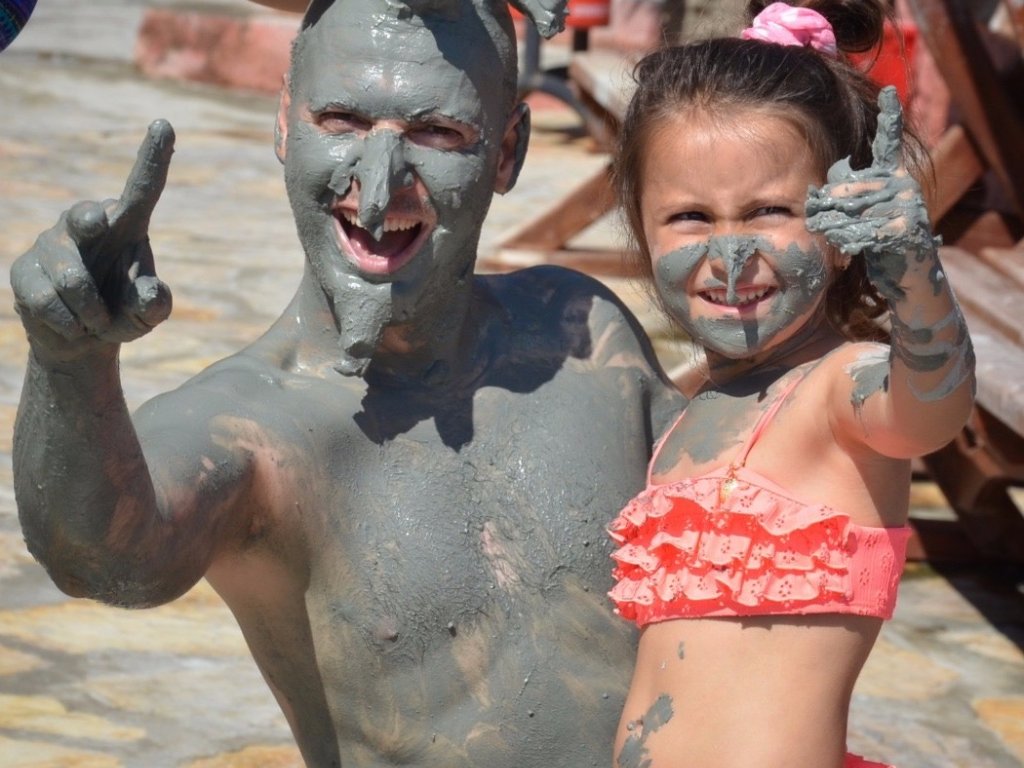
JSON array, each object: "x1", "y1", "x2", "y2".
[{"x1": 279, "y1": 0, "x2": 517, "y2": 294}]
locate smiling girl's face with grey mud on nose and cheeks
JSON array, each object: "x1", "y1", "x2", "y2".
[{"x1": 640, "y1": 110, "x2": 837, "y2": 359}]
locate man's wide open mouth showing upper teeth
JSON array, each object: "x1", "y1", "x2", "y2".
[{"x1": 334, "y1": 208, "x2": 431, "y2": 274}]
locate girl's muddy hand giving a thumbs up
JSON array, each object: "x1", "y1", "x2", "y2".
[{"x1": 807, "y1": 86, "x2": 937, "y2": 303}]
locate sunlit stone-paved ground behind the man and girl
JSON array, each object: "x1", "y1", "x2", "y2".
[{"x1": 0, "y1": 0, "x2": 1024, "y2": 768}]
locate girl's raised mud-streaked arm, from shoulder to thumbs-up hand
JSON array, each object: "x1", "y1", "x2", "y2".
[{"x1": 807, "y1": 88, "x2": 974, "y2": 458}]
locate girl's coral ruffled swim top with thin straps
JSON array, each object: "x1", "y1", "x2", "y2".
[{"x1": 608, "y1": 377, "x2": 910, "y2": 627}]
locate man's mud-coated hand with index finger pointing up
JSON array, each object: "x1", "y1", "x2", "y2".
[{"x1": 11, "y1": 120, "x2": 174, "y2": 360}]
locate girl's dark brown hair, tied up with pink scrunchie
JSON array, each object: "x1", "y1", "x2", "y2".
[{"x1": 613, "y1": 0, "x2": 924, "y2": 339}]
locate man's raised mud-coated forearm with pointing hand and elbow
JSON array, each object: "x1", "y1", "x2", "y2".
[{"x1": 11, "y1": 122, "x2": 253, "y2": 605}]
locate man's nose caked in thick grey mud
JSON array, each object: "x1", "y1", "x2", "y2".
[{"x1": 354, "y1": 130, "x2": 413, "y2": 240}]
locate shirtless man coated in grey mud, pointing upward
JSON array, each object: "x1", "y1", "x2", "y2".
[{"x1": 12, "y1": 0, "x2": 682, "y2": 768}]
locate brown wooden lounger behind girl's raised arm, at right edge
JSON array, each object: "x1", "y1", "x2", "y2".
[{"x1": 908, "y1": 0, "x2": 1024, "y2": 562}]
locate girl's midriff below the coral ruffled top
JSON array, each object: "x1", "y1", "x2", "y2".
[{"x1": 615, "y1": 615, "x2": 882, "y2": 768}]
